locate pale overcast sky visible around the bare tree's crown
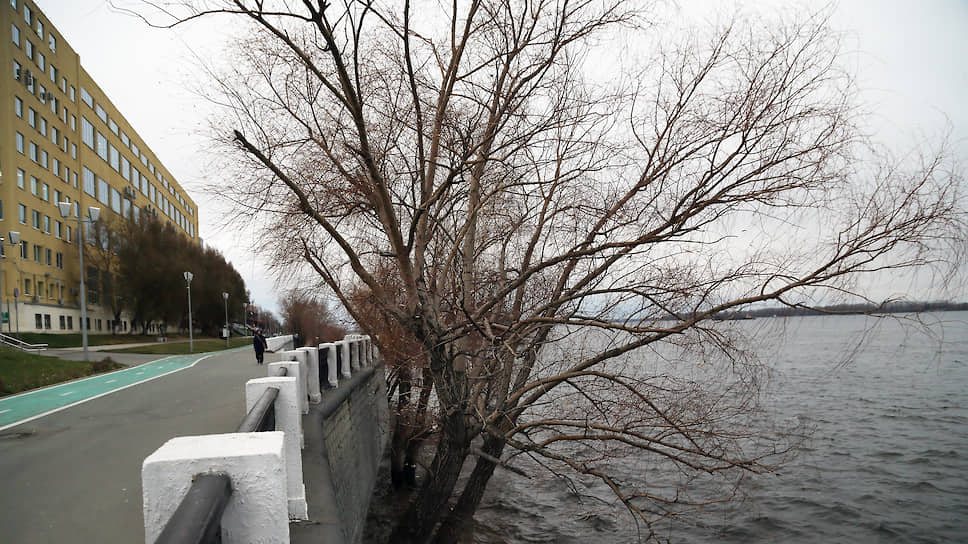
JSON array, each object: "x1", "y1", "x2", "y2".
[{"x1": 30, "y1": 0, "x2": 968, "y2": 310}]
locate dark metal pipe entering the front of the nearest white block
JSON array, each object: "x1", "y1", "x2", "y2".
[{"x1": 155, "y1": 472, "x2": 232, "y2": 544}]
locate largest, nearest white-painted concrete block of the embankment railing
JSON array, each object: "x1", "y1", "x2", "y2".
[{"x1": 141, "y1": 432, "x2": 289, "y2": 544}]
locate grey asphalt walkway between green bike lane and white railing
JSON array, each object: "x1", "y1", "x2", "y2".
[{"x1": 0, "y1": 350, "x2": 277, "y2": 543}]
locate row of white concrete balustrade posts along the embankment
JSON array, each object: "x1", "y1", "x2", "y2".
[{"x1": 142, "y1": 335, "x2": 375, "y2": 544}]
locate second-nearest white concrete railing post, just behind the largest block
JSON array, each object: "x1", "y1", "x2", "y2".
[{"x1": 245, "y1": 376, "x2": 309, "y2": 519}]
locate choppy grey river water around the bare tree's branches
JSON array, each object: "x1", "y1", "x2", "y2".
[{"x1": 464, "y1": 312, "x2": 968, "y2": 544}]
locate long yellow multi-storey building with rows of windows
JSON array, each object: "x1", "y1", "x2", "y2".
[{"x1": 0, "y1": 0, "x2": 199, "y2": 333}]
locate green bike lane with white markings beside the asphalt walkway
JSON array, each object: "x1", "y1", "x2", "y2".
[{"x1": 0, "y1": 348, "x2": 247, "y2": 431}]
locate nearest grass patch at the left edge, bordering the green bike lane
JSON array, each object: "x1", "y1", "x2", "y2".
[{"x1": 0, "y1": 347, "x2": 124, "y2": 396}]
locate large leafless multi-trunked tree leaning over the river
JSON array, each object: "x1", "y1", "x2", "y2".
[{"x1": 134, "y1": 0, "x2": 964, "y2": 542}]
